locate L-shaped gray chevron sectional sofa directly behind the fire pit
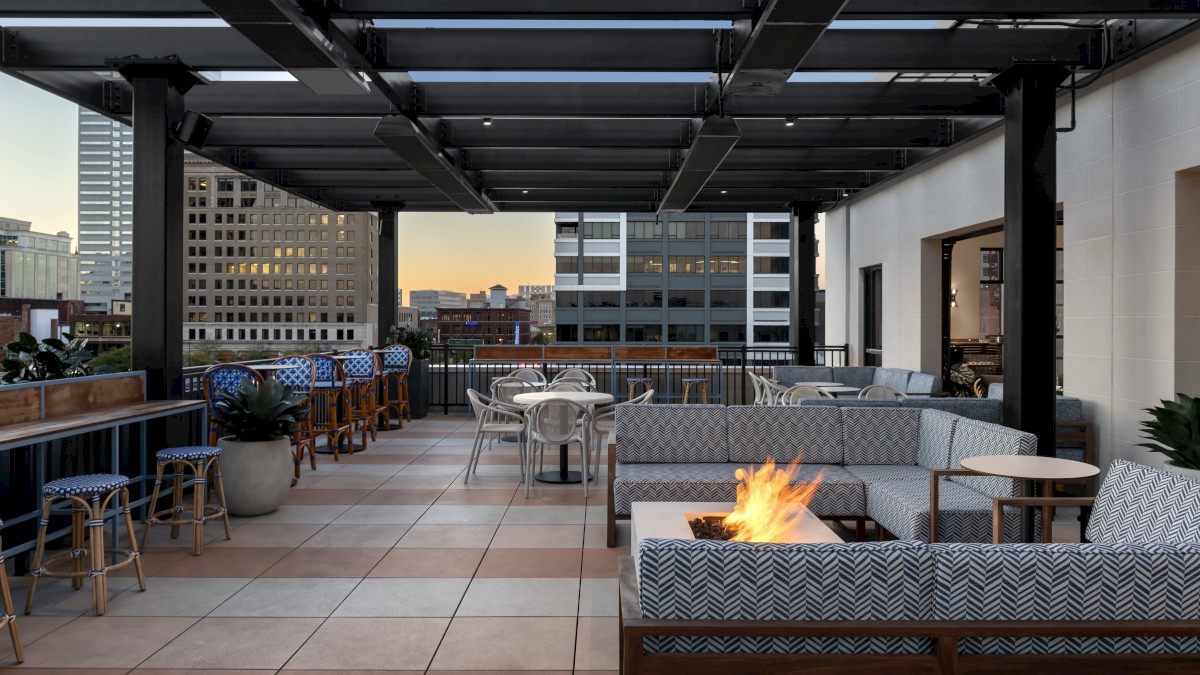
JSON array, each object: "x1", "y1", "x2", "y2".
[{"x1": 608, "y1": 405, "x2": 1037, "y2": 546}]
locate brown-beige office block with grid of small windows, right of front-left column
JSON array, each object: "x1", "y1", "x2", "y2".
[{"x1": 184, "y1": 155, "x2": 379, "y2": 353}]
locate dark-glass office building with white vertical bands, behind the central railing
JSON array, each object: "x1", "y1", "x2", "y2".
[{"x1": 554, "y1": 213, "x2": 821, "y2": 346}]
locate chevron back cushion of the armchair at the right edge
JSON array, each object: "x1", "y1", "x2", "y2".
[{"x1": 1087, "y1": 459, "x2": 1200, "y2": 544}]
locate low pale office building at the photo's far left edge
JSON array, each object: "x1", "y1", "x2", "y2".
[{"x1": 0, "y1": 217, "x2": 79, "y2": 300}]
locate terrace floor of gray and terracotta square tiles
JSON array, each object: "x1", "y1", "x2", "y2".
[{"x1": 0, "y1": 416, "x2": 629, "y2": 675}]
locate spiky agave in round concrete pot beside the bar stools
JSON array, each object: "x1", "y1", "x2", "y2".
[{"x1": 212, "y1": 378, "x2": 308, "y2": 515}]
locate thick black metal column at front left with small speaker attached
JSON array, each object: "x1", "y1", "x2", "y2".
[{"x1": 113, "y1": 58, "x2": 203, "y2": 399}]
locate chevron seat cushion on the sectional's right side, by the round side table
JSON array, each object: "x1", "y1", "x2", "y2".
[{"x1": 866, "y1": 478, "x2": 1021, "y2": 543}]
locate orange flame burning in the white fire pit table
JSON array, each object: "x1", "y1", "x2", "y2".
[{"x1": 725, "y1": 456, "x2": 824, "y2": 542}]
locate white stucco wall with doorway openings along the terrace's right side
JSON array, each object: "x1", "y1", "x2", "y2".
[{"x1": 826, "y1": 32, "x2": 1200, "y2": 465}]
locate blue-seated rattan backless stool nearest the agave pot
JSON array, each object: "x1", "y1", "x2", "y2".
[{"x1": 140, "y1": 446, "x2": 232, "y2": 555}]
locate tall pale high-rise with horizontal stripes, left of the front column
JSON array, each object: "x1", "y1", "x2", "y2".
[{"x1": 78, "y1": 108, "x2": 133, "y2": 312}]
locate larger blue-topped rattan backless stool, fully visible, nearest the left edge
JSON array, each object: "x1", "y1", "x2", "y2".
[{"x1": 25, "y1": 473, "x2": 146, "y2": 615}]
